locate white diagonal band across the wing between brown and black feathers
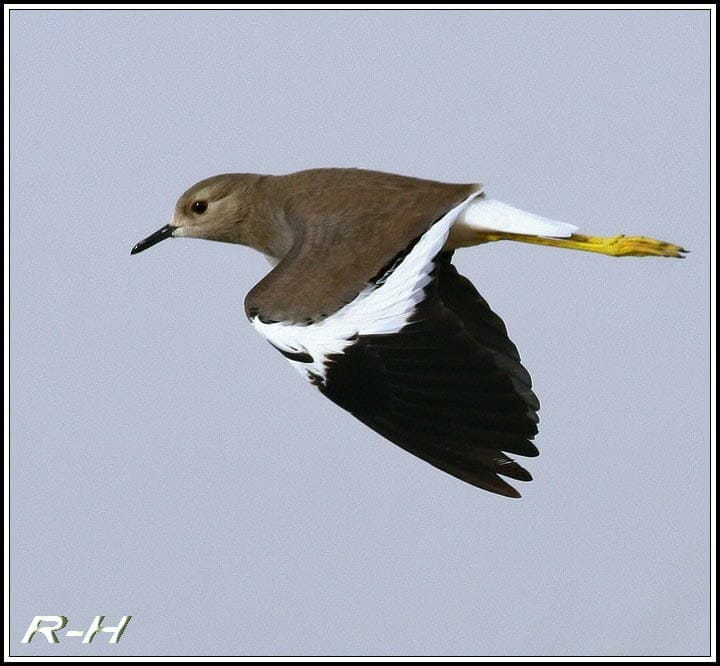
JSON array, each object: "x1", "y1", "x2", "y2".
[{"x1": 251, "y1": 193, "x2": 479, "y2": 383}]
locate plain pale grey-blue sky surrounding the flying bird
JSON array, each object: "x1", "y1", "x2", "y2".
[{"x1": 10, "y1": 10, "x2": 710, "y2": 656}]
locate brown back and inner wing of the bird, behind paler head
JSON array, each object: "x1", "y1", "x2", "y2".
[{"x1": 245, "y1": 169, "x2": 481, "y2": 323}]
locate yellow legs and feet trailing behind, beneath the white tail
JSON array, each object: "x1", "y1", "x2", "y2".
[{"x1": 476, "y1": 231, "x2": 687, "y2": 259}]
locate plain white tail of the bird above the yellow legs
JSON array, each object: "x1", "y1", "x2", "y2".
[{"x1": 457, "y1": 198, "x2": 577, "y2": 238}]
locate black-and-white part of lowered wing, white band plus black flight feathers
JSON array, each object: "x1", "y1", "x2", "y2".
[{"x1": 253, "y1": 195, "x2": 539, "y2": 497}]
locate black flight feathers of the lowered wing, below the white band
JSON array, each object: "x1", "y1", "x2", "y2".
[{"x1": 318, "y1": 256, "x2": 539, "y2": 497}]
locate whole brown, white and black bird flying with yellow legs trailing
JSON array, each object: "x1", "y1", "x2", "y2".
[{"x1": 131, "y1": 169, "x2": 686, "y2": 497}]
